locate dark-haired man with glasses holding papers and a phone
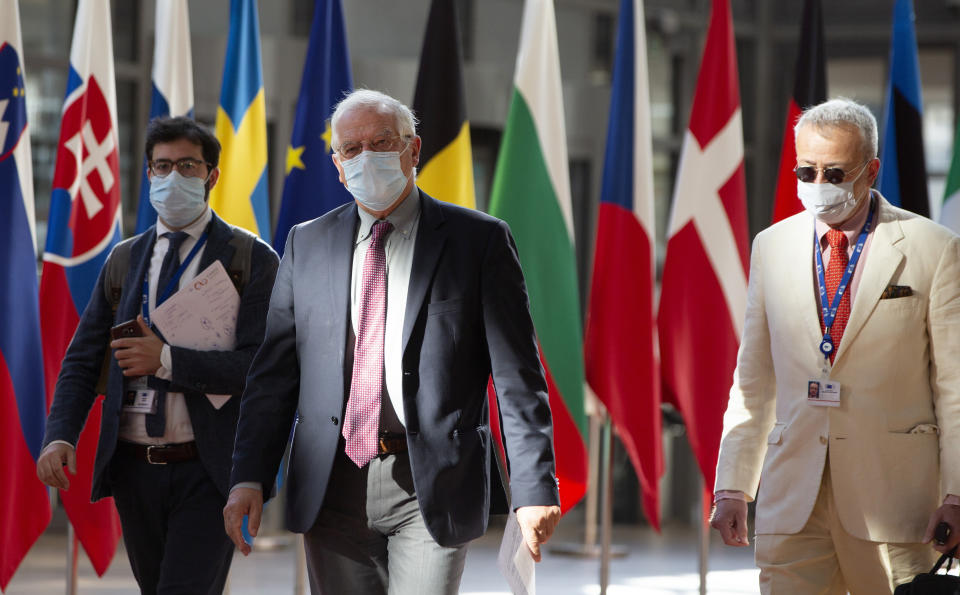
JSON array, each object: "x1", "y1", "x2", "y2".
[{"x1": 37, "y1": 118, "x2": 278, "y2": 594}]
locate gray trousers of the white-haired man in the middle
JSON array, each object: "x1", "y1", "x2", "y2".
[{"x1": 304, "y1": 450, "x2": 467, "y2": 595}]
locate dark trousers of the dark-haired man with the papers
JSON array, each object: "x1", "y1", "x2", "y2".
[{"x1": 111, "y1": 449, "x2": 234, "y2": 595}]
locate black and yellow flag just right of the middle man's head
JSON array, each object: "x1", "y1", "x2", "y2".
[{"x1": 413, "y1": 0, "x2": 477, "y2": 209}]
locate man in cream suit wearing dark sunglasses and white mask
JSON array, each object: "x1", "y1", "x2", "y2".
[{"x1": 712, "y1": 99, "x2": 960, "y2": 594}]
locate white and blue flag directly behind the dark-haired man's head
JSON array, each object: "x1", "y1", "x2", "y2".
[{"x1": 135, "y1": 0, "x2": 193, "y2": 233}]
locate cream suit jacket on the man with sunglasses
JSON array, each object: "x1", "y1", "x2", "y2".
[{"x1": 715, "y1": 193, "x2": 960, "y2": 542}]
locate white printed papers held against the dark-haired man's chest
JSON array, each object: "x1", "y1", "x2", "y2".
[{"x1": 150, "y1": 260, "x2": 240, "y2": 409}]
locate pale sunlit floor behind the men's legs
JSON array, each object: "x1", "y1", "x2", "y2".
[{"x1": 6, "y1": 519, "x2": 757, "y2": 595}]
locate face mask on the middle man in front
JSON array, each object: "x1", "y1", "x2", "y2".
[{"x1": 340, "y1": 144, "x2": 410, "y2": 212}]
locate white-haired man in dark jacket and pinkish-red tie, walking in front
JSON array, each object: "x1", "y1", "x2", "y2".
[{"x1": 224, "y1": 90, "x2": 560, "y2": 595}]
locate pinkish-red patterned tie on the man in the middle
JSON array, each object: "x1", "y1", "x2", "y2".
[{"x1": 343, "y1": 221, "x2": 393, "y2": 467}]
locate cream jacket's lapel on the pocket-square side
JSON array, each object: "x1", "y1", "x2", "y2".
[{"x1": 833, "y1": 198, "x2": 904, "y2": 366}]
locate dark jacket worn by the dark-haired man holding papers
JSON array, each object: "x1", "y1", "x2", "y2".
[{"x1": 43, "y1": 213, "x2": 278, "y2": 500}]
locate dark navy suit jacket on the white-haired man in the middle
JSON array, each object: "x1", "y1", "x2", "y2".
[{"x1": 231, "y1": 193, "x2": 559, "y2": 546}]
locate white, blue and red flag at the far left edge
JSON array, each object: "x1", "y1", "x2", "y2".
[{"x1": 0, "y1": 0, "x2": 50, "y2": 590}]
